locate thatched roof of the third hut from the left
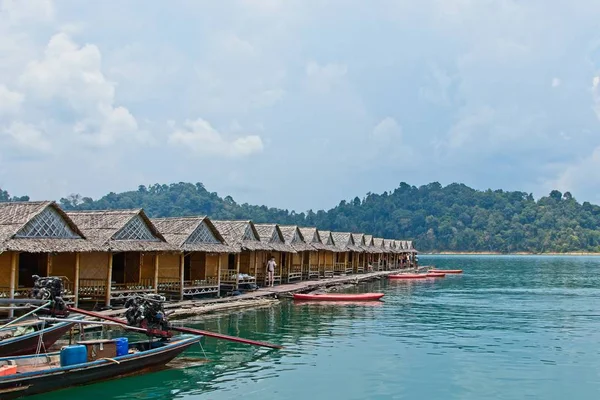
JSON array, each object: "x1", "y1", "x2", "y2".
[{"x1": 151, "y1": 216, "x2": 239, "y2": 253}]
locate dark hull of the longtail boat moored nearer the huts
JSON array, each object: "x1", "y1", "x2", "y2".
[{"x1": 0, "y1": 322, "x2": 82, "y2": 357}]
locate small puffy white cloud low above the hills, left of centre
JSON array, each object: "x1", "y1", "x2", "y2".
[{"x1": 169, "y1": 118, "x2": 264, "y2": 157}]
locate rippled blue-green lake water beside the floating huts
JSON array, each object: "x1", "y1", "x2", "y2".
[{"x1": 35, "y1": 256, "x2": 600, "y2": 400}]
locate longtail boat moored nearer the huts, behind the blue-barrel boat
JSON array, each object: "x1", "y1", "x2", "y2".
[{"x1": 0, "y1": 315, "x2": 83, "y2": 358}]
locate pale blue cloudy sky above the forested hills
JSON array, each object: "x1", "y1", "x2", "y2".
[{"x1": 0, "y1": 0, "x2": 600, "y2": 211}]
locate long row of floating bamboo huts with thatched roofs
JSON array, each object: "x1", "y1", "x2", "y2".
[{"x1": 0, "y1": 201, "x2": 416, "y2": 306}]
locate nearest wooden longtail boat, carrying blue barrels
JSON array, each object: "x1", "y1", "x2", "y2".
[{"x1": 0, "y1": 335, "x2": 202, "y2": 399}]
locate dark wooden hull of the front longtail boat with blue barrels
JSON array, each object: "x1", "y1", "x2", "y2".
[{"x1": 0, "y1": 336, "x2": 201, "y2": 399}]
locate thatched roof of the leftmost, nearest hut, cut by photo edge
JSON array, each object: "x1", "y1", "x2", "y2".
[{"x1": 0, "y1": 201, "x2": 93, "y2": 253}]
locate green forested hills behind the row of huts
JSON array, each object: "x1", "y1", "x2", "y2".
[{"x1": 0, "y1": 182, "x2": 600, "y2": 253}]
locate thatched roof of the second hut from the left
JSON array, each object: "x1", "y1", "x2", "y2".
[{"x1": 67, "y1": 208, "x2": 180, "y2": 251}]
